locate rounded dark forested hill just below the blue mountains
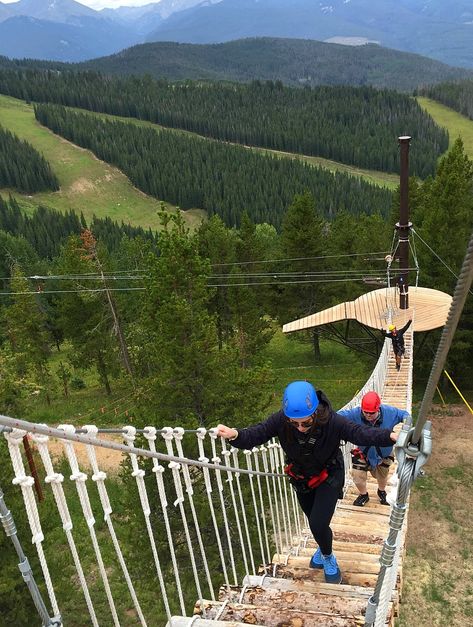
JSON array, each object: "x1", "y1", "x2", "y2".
[{"x1": 80, "y1": 37, "x2": 472, "y2": 91}]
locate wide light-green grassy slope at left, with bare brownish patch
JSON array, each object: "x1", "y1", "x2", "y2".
[{"x1": 0, "y1": 96, "x2": 203, "y2": 229}]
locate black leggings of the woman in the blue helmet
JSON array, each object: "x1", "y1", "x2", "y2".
[{"x1": 296, "y1": 483, "x2": 340, "y2": 555}]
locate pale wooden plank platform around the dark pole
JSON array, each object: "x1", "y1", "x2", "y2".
[{"x1": 283, "y1": 287, "x2": 452, "y2": 333}]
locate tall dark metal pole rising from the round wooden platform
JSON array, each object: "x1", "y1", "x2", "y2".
[{"x1": 396, "y1": 135, "x2": 412, "y2": 309}]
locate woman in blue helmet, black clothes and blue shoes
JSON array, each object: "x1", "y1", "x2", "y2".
[{"x1": 216, "y1": 381, "x2": 397, "y2": 584}]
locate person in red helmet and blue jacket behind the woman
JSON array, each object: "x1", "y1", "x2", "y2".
[{"x1": 337, "y1": 392, "x2": 409, "y2": 507}]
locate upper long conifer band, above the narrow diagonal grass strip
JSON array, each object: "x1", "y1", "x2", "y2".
[{"x1": 0, "y1": 71, "x2": 448, "y2": 178}]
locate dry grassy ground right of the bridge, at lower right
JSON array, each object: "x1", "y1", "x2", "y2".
[{"x1": 397, "y1": 406, "x2": 473, "y2": 627}]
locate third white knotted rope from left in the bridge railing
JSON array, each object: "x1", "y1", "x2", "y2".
[{"x1": 58, "y1": 425, "x2": 120, "y2": 627}]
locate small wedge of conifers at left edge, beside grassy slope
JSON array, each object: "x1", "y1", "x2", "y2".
[{"x1": 0, "y1": 125, "x2": 59, "y2": 194}]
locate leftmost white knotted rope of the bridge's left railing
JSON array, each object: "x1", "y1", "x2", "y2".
[{"x1": 4, "y1": 429, "x2": 60, "y2": 616}]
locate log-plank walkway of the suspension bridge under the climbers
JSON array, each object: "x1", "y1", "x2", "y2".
[{"x1": 192, "y1": 330, "x2": 413, "y2": 627}]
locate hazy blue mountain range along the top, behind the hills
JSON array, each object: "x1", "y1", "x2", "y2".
[{"x1": 0, "y1": 0, "x2": 473, "y2": 68}]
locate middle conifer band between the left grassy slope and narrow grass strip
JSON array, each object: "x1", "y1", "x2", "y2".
[{"x1": 35, "y1": 105, "x2": 391, "y2": 227}]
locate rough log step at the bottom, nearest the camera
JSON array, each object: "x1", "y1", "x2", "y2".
[{"x1": 194, "y1": 600, "x2": 364, "y2": 627}]
